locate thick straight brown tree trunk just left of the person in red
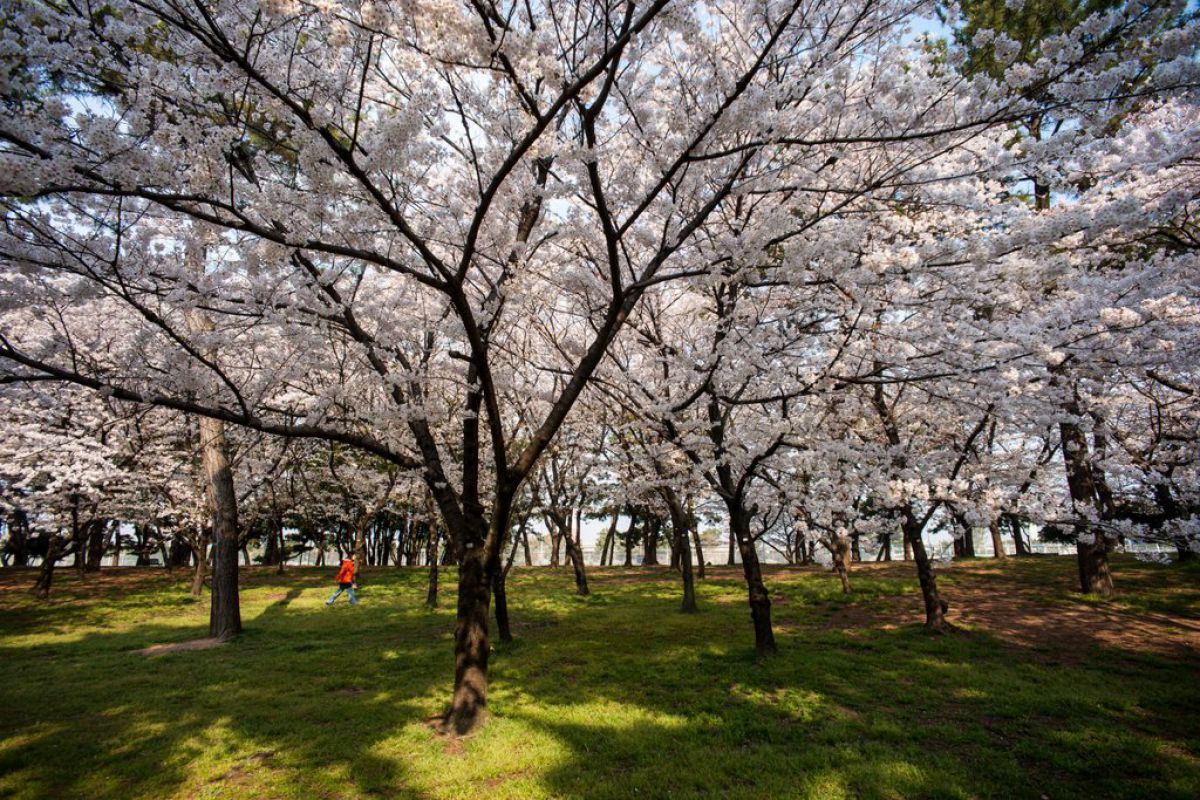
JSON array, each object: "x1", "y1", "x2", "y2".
[{"x1": 200, "y1": 417, "x2": 241, "y2": 642}]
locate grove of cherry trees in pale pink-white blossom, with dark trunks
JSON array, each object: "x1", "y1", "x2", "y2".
[{"x1": 0, "y1": 0, "x2": 1200, "y2": 733}]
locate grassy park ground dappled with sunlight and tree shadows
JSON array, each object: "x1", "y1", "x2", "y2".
[{"x1": 0, "y1": 558, "x2": 1200, "y2": 800}]
